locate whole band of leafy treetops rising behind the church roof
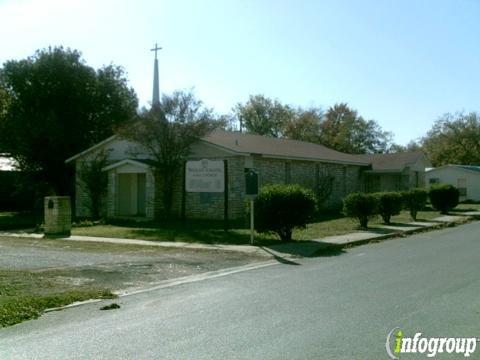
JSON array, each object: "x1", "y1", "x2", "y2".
[{"x1": 234, "y1": 95, "x2": 392, "y2": 154}]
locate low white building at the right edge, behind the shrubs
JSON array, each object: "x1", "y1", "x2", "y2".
[{"x1": 425, "y1": 165, "x2": 480, "y2": 201}]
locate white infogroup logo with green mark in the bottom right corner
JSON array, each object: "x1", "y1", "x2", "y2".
[{"x1": 385, "y1": 327, "x2": 478, "y2": 360}]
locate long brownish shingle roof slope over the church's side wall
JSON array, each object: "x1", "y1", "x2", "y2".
[{"x1": 202, "y1": 130, "x2": 369, "y2": 165}]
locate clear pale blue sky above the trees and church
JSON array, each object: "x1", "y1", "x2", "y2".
[{"x1": 0, "y1": 0, "x2": 480, "y2": 144}]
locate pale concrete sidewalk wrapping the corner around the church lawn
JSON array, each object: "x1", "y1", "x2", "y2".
[{"x1": 0, "y1": 211, "x2": 480, "y2": 259}]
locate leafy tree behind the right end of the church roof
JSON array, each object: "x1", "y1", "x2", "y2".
[{"x1": 320, "y1": 103, "x2": 391, "y2": 154}]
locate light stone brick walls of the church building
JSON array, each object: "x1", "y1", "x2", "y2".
[{"x1": 77, "y1": 156, "x2": 362, "y2": 220}]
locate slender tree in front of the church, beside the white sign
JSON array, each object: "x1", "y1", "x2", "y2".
[{"x1": 120, "y1": 91, "x2": 218, "y2": 219}]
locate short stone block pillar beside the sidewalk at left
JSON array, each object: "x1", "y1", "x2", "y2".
[{"x1": 44, "y1": 196, "x2": 72, "y2": 237}]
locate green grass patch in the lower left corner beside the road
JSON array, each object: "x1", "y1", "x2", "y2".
[{"x1": 0, "y1": 270, "x2": 115, "y2": 327}]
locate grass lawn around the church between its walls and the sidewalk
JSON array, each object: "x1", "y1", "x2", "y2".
[{"x1": 72, "y1": 204, "x2": 480, "y2": 245}]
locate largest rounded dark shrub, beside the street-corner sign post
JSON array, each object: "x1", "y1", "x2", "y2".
[{"x1": 255, "y1": 184, "x2": 315, "y2": 241}]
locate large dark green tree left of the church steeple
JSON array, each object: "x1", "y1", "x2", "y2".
[{"x1": 0, "y1": 47, "x2": 137, "y2": 194}]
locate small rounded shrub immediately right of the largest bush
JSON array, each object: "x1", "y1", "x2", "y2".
[{"x1": 343, "y1": 193, "x2": 378, "y2": 228}]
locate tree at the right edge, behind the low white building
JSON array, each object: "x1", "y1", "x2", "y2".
[{"x1": 422, "y1": 112, "x2": 480, "y2": 166}]
